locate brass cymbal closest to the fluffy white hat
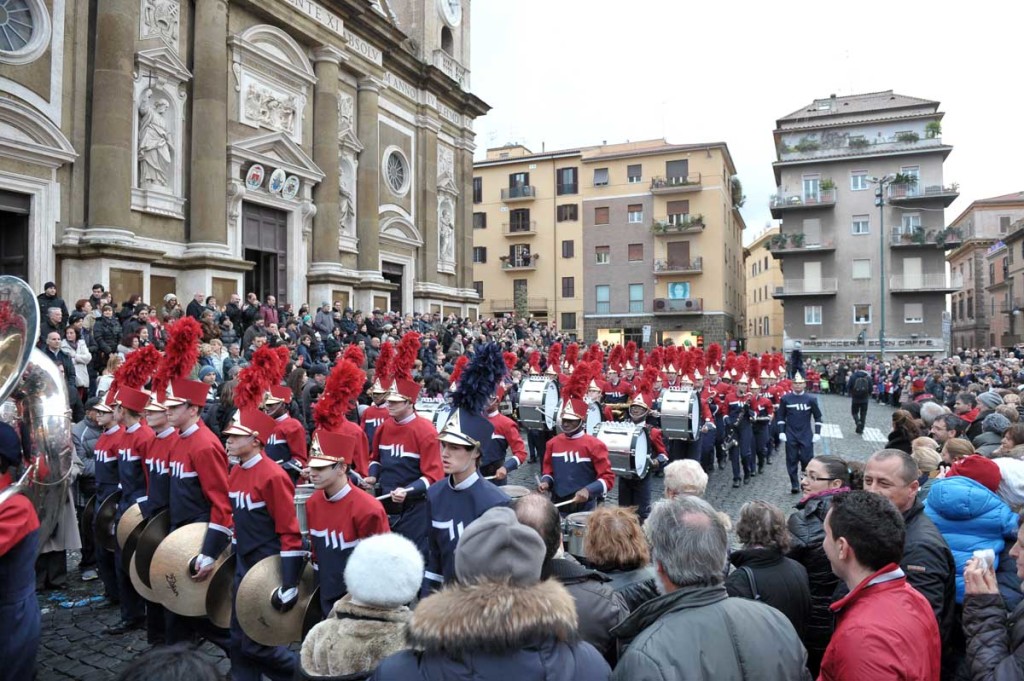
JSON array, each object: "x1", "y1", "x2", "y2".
[{"x1": 234, "y1": 554, "x2": 315, "y2": 645}]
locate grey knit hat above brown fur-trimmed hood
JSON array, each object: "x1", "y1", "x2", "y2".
[{"x1": 455, "y1": 506, "x2": 547, "y2": 587}]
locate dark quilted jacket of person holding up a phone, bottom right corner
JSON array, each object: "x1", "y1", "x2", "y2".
[{"x1": 964, "y1": 594, "x2": 1024, "y2": 681}]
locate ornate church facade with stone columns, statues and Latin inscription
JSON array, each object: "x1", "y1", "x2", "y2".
[{"x1": 0, "y1": 0, "x2": 488, "y2": 315}]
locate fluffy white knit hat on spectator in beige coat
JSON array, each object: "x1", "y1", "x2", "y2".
[{"x1": 345, "y1": 533, "x2": 423, "y2": 609}]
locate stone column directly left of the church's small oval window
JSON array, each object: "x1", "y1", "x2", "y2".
[{"x1": 355, "y1": 77, "x2": 381, "y2": 276}]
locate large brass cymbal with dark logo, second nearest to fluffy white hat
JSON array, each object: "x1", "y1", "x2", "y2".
[{"x1": 150, "y1": 522, "x2": 228, "y2": 618}]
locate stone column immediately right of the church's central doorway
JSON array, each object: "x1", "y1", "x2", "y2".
[{"x1": 312, "y1": 46, "x2": 344, "y2": 264}]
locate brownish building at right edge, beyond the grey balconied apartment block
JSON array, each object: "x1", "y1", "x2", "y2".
[{"x1": 946, "y1": 191, "x2": 1024, "y2": 347}]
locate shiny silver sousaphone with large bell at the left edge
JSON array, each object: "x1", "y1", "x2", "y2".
[{"x1": 0, "y1": 275, "x2": 75, "y2": 546}]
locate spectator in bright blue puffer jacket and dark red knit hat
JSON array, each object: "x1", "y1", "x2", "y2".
[{"x1": 925, "y1": 455, "x2": 1021, "y2": 609}]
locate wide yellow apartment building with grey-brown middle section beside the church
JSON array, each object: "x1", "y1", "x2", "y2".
[{"x1": 473, "y1": 139, "x2": 745, "y2": 345}]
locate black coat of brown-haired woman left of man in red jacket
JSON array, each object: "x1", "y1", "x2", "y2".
[{"x1": 725, "y1": 547, "x2": 811, "y2": 640}]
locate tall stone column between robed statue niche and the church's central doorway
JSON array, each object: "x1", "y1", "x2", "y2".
[{"x1": 188, "y1": 0, "x2": 229, "y2": 249}]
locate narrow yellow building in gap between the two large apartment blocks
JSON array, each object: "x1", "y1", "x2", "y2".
[{"x1": 744, "y1": 226, "x2": 782, "y2": 353}]
